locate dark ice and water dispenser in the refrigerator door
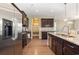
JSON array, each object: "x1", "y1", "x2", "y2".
[{"x1": 3, "y1": 19, "x2": 12, "y2": 39}]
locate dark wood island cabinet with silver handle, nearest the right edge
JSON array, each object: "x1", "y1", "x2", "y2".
[{"x1": 63, "y1": 41, "x2": 79, "y2": 55}]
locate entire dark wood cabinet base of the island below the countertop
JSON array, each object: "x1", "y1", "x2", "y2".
[{"x1": 49, "y1": 34, "x2": 79, "y2": 55}]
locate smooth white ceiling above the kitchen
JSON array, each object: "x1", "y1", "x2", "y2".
[{"x1": 15, "y1": 3, "x2": 79, "y2": 19}]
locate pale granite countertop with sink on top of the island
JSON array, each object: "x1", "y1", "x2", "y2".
[{"x1": 48, "y1": 32, "x2": 79, "y2": 46}]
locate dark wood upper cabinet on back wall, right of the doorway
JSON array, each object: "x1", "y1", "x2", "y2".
[{"x1": 41, "y1": 18, "x2": 54, "y2": 27}]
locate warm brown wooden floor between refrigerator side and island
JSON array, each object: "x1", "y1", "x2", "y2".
[{"x1": 23, "y1": 38, "x2": 54, "y2": 55}]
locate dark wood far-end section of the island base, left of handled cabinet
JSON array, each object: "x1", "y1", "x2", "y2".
[{"x1": 49, "y1": 35, "x2": 63, "y2": 55}]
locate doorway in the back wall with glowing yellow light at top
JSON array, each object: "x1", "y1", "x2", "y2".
[{"x1": 32, "y1": 18, "x2": 40, "y2": 38}]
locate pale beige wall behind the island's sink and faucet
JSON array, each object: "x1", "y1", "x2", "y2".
[{"x1": 56, "y1": 19, "x2": 79, "y2": 33}]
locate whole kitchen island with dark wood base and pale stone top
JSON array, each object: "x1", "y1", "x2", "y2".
[{"x1": 48, "y1": 32, "x2": 79, "y2": 55}]
